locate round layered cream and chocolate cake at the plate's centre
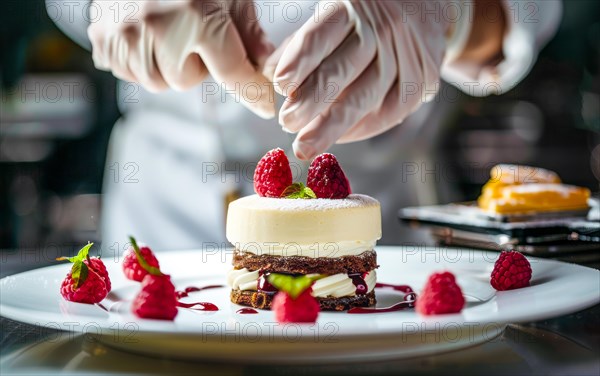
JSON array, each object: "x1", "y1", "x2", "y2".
[{"x1": 226, "y1": 149, "x2": 381, "y2": 311}]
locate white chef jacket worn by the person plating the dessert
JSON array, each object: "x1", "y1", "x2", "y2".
[{"x1": 46, "y1": 0, "x2": 562, "y2": 252}]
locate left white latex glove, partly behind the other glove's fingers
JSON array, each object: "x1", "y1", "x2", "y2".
[{"x1": 88, "y1": 0, "x2": 275, "y2": 118}]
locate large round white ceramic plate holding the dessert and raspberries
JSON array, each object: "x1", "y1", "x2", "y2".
[{"x1": 0, "y1": 247, "x2": 600, "y2": 362}]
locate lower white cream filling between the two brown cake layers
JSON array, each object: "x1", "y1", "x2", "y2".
[{"x1": 227, "y1": 268, "x2": 377, "y2": 298}]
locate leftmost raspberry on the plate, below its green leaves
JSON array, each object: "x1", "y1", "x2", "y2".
[{"x1": 60, "y1": 268, "x2": 108, "y2": 304}]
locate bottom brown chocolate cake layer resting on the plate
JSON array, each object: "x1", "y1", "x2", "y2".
[{"x1": 231, "y1": 290, "x2": 377, "y2": 311}]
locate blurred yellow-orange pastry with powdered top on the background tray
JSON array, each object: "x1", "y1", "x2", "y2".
[{"x1": 478, "y1": 164, "x2": 590, "y2": 214}]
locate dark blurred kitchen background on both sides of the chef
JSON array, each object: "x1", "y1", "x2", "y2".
[{"x1": 0, "y1": 0, "x2": 600, "y2": 252}]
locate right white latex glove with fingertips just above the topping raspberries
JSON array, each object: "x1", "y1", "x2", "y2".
[{"x1": 265, "y1": 0, "x2": 450, "y2": 159}]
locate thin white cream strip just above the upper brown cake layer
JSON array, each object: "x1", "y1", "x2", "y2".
[{"x1": 234, "y1": 239, "x2": 377, "y2": 258}]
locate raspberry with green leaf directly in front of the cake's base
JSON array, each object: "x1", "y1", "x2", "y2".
[{"x1": 271, "y1": 287, "x2": 320, "y2": 323}]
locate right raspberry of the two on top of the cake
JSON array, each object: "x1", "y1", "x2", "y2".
[{"x1": 306, "y1": 153, "x2": 351, "y2": 198}]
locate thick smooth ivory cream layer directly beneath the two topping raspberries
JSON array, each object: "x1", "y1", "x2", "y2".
[{"x1": 226, "y1": 194, "x2": 381, "y2": 257}]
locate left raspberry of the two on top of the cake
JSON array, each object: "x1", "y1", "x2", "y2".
[{"x1": 254, "y1": 148, "x2": 292, "y2": 197}]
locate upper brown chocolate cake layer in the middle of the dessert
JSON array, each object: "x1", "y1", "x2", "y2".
[{"x1": 233, "y1": 249, "x2": 379, "y2": 275}]
